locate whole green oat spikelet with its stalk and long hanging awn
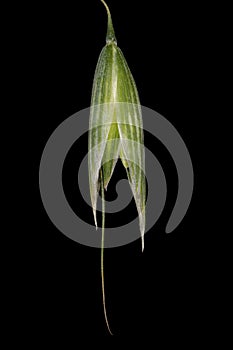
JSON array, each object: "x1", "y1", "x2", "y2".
[{"x1": 88, "y1": 0, "x2": 146, "y2": 332}]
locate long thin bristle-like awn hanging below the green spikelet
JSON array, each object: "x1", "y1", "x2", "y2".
[{"x1": 100, "y1": 169, "x2": 113, "y2": 335}]
